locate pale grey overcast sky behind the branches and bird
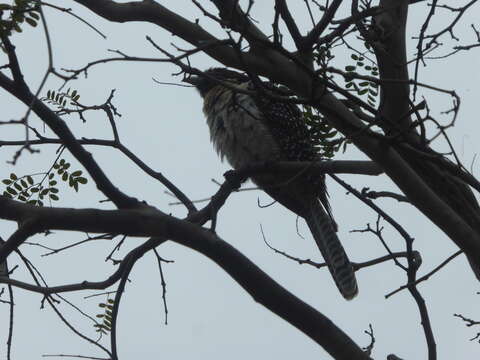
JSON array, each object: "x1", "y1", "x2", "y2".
[{"x1": 0, "y1": 0, "x2": 480, "y2": 360}]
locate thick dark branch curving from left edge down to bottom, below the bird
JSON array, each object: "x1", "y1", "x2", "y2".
[{"x1": 0, "y1": 197, "x2": 369, "y2": 360}]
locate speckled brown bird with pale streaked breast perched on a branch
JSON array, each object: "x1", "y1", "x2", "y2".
[{"x1": 184, "y1": 68, "x2": 358, "y2": 300}]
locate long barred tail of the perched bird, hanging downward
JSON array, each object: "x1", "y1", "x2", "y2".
[{"x1": 305, "y1": 200, "x2": 358, "y2": 300}]
